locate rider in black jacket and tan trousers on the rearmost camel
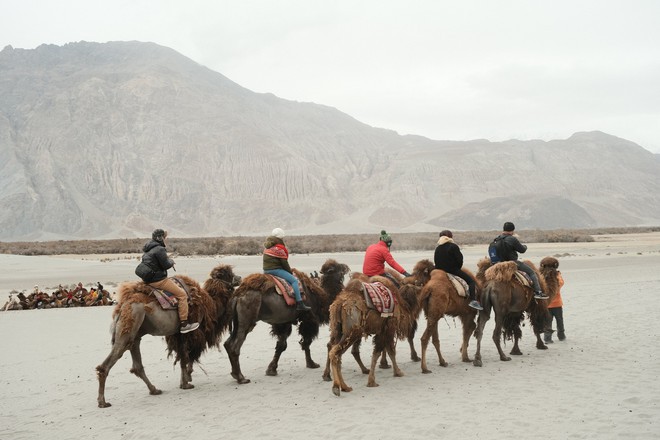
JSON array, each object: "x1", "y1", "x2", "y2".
[{"x1": 141, "y1": 229, "x2": 199, "y2": 333}]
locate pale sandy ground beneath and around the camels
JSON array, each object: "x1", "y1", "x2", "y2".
[{"x1": 0, "y1": 233, "x2": 660, "y2": 439}]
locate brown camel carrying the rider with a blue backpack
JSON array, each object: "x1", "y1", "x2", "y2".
[{"x1": 473, "y1": 259, "x2": 548, "y2": 367}]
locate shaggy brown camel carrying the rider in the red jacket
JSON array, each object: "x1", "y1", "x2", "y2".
[{"x1": 328, "y1": 276, "x2": 419, "y2": 396}]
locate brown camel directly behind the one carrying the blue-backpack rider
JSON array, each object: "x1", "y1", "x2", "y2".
[{"x1": 419, "y1": 268, "x2": 480, "y2": 373}]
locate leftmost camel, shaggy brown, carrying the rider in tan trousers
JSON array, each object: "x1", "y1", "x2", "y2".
[{"x1": 96, "y1": 265, "x2": 240, "y2": 408}]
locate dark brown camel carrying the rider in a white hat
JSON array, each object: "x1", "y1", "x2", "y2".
[{"x1": 225, "y1": 259, "x2": 350, "y2": 384}]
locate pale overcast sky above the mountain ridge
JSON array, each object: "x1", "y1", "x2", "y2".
[{"x1": 0, "y1": 0, "x2": 660, "y2": 153}]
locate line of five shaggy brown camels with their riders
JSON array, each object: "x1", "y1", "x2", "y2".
[{"x1": 87, "y1": 223, "x2": 560, "y2": 408}]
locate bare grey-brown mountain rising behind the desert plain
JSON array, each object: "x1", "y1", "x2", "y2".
[{"x1": 0, "y1": 42, "x2": 660, "y2": 241}]
